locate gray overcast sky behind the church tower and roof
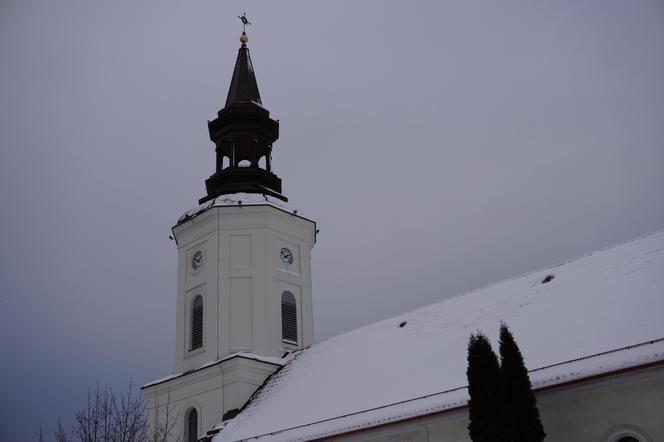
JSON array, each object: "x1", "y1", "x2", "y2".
[{"x1": 0, "y1": 0, "x2": 664, "y2": 440}]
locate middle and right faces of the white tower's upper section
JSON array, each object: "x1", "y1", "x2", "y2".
[{"x1": 215, "y1": 206, "x2": 315, "y2": 357}]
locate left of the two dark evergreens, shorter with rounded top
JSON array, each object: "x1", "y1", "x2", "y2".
[{"x1": 466, "y1": 333, "x2": 508, "y2": 442}]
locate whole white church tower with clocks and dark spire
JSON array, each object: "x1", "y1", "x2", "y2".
[{"x1": 143, "y1": 27, "x2": 316, "y2": 442}]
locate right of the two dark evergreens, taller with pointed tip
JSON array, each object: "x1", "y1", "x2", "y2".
[{"x1": 500, "y1": 323, "x2": 546, "y2": 442}]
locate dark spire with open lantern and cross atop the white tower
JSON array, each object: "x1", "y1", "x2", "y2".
[{"x1": 199, "y1": 28, "x2": 288, "y2": 203}]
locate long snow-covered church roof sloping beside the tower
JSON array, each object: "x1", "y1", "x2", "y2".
[{"x1": 214, "y1": 232, "x2": 664, "y2": 442}]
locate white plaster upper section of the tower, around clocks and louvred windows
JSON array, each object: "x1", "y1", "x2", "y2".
[{"x1": 173, "y1": 206, "x2": 315, "y2": 372}]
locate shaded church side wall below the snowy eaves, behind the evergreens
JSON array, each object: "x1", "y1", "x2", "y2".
[{"x1": 326, "y1": 366, "x2": 664, "y2": 442}]
